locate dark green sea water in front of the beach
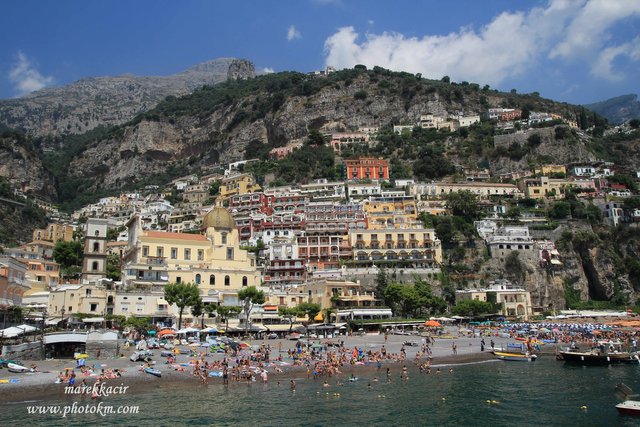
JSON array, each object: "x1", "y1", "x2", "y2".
[{"x1": 5, "y1": 358, "x2": 640, "y2": 427}]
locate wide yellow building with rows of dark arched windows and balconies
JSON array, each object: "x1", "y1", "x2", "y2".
[{"x1": 349, "y1": 224, "x2": 442, "y2": 268}]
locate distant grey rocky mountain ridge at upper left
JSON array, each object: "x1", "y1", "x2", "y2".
[{"x1": 0, "y1": 58, "x2": 255, "y2": 136}]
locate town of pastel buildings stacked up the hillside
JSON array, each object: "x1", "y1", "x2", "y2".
[{"x1": 0, "y1": 108, "x2": 640, "y2": 350}]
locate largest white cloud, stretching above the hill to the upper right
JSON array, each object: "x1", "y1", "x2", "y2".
[{"x1": 324, "y1": 0, "x2": 640, "y2": 85}]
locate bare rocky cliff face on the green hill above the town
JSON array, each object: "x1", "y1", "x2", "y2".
[{"x1": 63, "y1": 70, "x2": 589, "y2": 192}]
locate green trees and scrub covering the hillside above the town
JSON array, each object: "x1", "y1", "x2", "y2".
[{"x1": 8, "y1": 66, "x2": 620, "y2": 211}]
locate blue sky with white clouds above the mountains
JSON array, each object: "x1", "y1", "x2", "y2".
[{"x1": 0, "y1": 0, "x2": 640, "y2": 103}]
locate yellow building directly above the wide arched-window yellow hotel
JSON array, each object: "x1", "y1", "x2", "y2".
[{"x1": 362, "y1": 196, "x2": 418, "y2": 229}]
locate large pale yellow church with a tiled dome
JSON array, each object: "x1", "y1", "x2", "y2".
[{"x1": 124, "y1": 207, "x2": 260, "y2": 305}]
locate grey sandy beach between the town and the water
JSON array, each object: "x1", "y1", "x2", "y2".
[{"x1": 0, "y1": 335, "x2": 528, "y2": 402}]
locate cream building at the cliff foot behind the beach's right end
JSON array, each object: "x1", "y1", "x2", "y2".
[{"x1": 456, "y1": 280, "x2": 533, "y2": 320}]
